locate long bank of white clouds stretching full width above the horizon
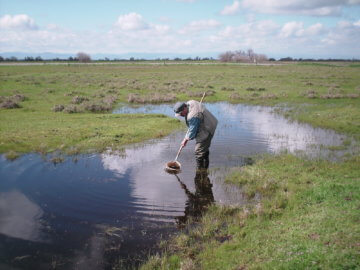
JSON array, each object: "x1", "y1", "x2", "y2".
[{"x1": 0, "y1": 13, "x2": 360, "y2": 58}]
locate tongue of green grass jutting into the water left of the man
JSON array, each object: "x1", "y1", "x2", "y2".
[{"x1": 0, "y1": 111, "x2": 180, "y2": 154}]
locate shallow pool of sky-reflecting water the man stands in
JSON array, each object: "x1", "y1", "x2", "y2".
[{"x1": 0, "y1": 103, "x2": 354, "y2": 269}]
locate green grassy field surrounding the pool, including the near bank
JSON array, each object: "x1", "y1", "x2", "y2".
[{"x1": 0, "y1": 63, "x2": 360, "y2": 269}]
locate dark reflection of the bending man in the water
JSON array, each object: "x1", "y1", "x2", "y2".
[{"x1": 176, "y1": 170, "x2": 214, "y2": 226}]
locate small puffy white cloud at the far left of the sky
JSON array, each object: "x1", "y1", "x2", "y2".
[{"x1": 0, "y1": 14, "x2": 38, "y2": 30}]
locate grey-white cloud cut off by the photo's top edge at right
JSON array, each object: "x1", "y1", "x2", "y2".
[{"x1": 242, "y1": 0, "x2": 360, "y2": 16}]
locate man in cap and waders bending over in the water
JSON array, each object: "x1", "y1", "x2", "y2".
[{"x1": 174, "y1": 100, "x2": 218, "y2": 169}]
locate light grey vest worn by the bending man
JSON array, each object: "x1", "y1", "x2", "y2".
[{"x1": 186, "y1": 100, "x2": 218, "y2": 142}]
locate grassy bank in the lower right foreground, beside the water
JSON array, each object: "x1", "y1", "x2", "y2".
[{"x1": 142, "y1": 154, "x2": 360, "y2": 269}]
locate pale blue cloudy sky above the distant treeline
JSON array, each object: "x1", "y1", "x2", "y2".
[{"x1": 0, "y1": 0, "x2": 360, "y2": 59}]
